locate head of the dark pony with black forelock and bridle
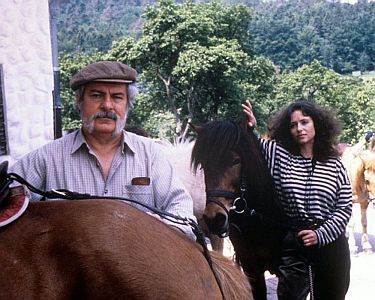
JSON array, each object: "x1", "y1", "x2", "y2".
[{"x1": 192, "y1": 121, "x2": 274, "y2": 236}]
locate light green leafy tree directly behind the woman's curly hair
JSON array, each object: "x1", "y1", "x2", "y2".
[{"x1": 268, "y1": 61, "x2": 375, "y2": 143}]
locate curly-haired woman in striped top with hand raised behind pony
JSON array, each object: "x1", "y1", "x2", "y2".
[{"x1": 242, "y1": 100, "x2": 352, "y2": 300}]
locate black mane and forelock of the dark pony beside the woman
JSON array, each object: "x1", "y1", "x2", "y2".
[{"x1": 192, "y1": 121, "x2": 281, "y2": 218}]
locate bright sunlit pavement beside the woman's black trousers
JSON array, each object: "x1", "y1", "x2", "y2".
[{"x1": 267, "y1": 204, "x2": 375, "y2": 300}]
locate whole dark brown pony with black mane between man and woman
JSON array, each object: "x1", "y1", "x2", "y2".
[{"x1": 192, "y1": 121, "x2": 288, "y2": 300}]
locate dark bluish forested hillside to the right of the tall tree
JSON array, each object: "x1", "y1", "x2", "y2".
[{"x1": 250, "y1": 0, "x2": 375, "y2": 74}]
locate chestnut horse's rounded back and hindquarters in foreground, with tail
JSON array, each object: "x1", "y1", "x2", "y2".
[{"x1": 0, "y1": 200, "x2": 251, "y2": 300}]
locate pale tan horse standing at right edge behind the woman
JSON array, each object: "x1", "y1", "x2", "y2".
[{"x1": 342, "y1": 147, "x2": 375, "y2": 253}]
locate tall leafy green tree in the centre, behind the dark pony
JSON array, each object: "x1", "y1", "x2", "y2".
[{"x1": 108, "y1": 0, "x2": 274, "y2": 138}]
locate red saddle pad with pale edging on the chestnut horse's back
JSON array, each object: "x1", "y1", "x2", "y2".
[{"x1": 0, "y1": 186, "x2": 30, "y2": 227}]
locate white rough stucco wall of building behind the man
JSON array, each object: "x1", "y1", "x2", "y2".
[{"x1": 0, "y1": 0, "x2": 54, "y2": 164}]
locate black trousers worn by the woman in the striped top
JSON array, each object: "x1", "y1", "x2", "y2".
[{"x1": 277, "y1": 232, "x2": 350, "y2": 300}]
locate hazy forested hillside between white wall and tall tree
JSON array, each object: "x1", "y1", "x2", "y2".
[{"x1": 57, "y1": 0, "x2": 145, "y2": 54}]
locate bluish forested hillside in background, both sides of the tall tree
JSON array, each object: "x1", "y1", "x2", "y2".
[{"x1": 58, "y1": 0, "x2": 375, "y2": 74}]
